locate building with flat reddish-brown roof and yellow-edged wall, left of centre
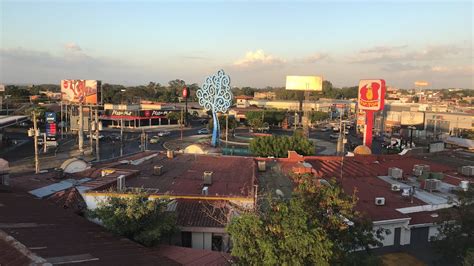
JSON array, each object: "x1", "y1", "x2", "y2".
[{"x1": 76, "y1": 153, "x2": 256, "y2": 251}]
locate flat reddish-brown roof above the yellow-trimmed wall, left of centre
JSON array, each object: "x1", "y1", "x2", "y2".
[{"x1": 117, "y1": 154, "x2": 256, "y2": 197}]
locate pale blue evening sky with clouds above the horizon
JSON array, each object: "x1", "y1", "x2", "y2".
[{"x1": 0, "y1": 0, "x2": 474, "y2": 89}]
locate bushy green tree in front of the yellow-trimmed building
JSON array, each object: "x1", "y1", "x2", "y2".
[{"x1": 88, "y1": 192, "x2": 176, "y2": 246}]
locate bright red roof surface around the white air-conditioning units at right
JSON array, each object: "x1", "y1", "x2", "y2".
[{"x1": 279, "y1": 155, "x2": 460, "y2": 222}]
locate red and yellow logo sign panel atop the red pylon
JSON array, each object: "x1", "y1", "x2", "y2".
[{"x1": 358, "y1": 79, "x2": 386, "y2": 111}]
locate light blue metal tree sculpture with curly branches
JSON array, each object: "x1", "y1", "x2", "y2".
[{"x1": 196, "y1": 69, "x2": 232, "y2": 147}]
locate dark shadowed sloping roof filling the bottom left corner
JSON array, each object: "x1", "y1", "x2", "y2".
[{"x1": 0, "y1": 192, "x2": 179, "y2": 265}]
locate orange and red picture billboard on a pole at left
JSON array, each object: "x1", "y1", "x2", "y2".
[{"x1": 61, "y1": 79, "x2": 102, "y2": 105}]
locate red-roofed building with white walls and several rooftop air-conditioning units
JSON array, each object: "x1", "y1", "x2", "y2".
[{"x1": 257, "y1": 152, "x2": 474, "y2": 249}]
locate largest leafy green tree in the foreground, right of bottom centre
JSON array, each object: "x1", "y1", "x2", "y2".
[{"x1": 227, "y1": 175, "x2": 381, "y2": 265}]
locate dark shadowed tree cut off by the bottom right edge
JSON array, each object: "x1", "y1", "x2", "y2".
[{"x1": 434, "y1": 185, "x2": 474, "y2": 262}]
